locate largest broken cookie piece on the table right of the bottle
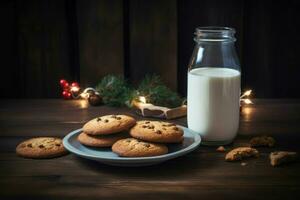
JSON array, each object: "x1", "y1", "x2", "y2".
[{"x1": 225, "y1": 147, "x2": 259, "y2": 161}]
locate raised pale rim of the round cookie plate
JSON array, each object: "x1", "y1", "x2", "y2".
[{"x1": 63, "y1": 125, "x2": 201, "y2": 163}]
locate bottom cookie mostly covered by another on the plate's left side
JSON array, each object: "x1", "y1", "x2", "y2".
[{"x1": 77, "y1": 132, "x2": 128, "y2": 147}]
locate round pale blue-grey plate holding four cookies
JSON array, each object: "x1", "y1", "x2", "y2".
[{"x1": 63, "y1": 126, "x2": 201, "y2": 167}]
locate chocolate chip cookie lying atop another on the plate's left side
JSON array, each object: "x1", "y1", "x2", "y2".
[{"x1": 82, "y1": 115, "x2": 135, "y2": 135}]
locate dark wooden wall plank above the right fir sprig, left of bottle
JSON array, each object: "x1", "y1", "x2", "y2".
[{"x1": 129, "y1": 0, "x2": 177, "y2": 90}]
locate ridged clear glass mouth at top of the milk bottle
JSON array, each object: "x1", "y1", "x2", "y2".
[{"x1": 194, "y1": 26, "x2": 236, "y2": 42}]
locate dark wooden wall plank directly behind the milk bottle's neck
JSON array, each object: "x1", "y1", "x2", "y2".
[{"x1": 178, "y1": 0, "x2": 243, "y2": 95}]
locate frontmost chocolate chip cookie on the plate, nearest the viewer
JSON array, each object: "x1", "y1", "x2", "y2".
[{"x1": 112, "y1": 138, "x2": 168, "y2": 157}]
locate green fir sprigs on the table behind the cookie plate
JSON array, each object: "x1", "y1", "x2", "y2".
[{"x1": 95, "y1": 75, "x2": 183, "y2": 108}]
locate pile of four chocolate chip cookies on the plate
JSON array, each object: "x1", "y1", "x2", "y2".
[{"x1": 78, "y1": 115, "x2": 183, "y2": 157}]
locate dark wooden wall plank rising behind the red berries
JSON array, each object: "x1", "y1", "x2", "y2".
[{"x1": 17, "y1": 0, "x2": 72, "y2": 98}]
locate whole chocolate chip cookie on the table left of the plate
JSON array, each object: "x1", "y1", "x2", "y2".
[{"x1": 16, "y1": 137, "x2": 67, "y2": 158}]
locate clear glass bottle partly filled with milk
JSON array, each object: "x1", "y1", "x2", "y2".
[{"x1": 187, "y1": 27, "x2": 241, "y2": 145}]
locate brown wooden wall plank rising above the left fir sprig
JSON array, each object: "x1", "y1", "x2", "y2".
[{"x1": 77, "y1": 0, "x2": 124, "y2": 86}]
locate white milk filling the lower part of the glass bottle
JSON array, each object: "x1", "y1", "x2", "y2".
[{"x1": 187, "y1": 67, "x2": 241, "y2": 145}]
